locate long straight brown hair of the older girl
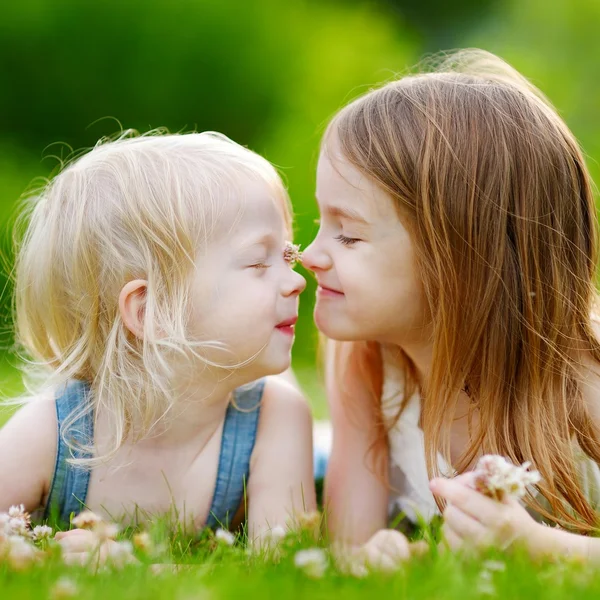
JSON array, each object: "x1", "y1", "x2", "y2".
[{"x1": 324, "y1": 50, "x2": 600, "y2": 532}]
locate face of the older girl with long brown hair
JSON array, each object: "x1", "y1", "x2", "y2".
[{"x1": 302, "y1": 140, "x2": 429, "y2": 345}]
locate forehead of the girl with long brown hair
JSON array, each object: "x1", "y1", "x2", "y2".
[{"x1": 317, "y1": 138, "x2": 397, "y2": 221}]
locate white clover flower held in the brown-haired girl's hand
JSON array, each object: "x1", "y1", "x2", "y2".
[{"x1": 473, "y1": 454, "x2": 541, "y2": 500}]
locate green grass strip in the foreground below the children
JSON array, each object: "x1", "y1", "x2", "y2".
[{"x1": 0, "y1": 538, "x2": 600, "y2": 600}]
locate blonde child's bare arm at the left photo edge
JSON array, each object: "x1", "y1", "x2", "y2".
[{"x1": 0, "y1": 399, "x2": 57, "y2": 512}]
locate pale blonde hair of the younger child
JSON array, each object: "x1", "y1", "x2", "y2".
[{"x1": 15, "y1": 132, "x2": 291, "y2": 464}]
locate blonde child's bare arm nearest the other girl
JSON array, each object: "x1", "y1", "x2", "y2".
[{"x1": 248, "y1": 377, "x2": 316, "y2": 541}]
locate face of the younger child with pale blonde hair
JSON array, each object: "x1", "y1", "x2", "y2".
[{"x1": 186, "y1": 180, "x2": 306, "y2": 381}]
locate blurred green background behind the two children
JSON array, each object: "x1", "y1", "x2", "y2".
[{"x1": 0, "y1": 0, "x2": 600, "y2": 417}]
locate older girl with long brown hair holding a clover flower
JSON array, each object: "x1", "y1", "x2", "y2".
[{"x1": 303, "y1": 50, "x2": 600, "y2": 557}]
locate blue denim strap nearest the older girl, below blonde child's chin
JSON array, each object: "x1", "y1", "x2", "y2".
[{"x1": 206, "y1": 379, "x2": 265, "y2": 529}]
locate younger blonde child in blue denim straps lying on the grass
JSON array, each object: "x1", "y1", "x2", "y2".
[{"x1": 0, "y1": 133, "x2": 315, "y2": 540}]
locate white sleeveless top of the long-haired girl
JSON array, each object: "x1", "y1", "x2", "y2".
[{"x1": 381, "y1": 346, "x2": 600, "y2": 523}]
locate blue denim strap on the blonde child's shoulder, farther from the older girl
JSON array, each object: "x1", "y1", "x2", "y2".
[{"x1": 44, "y1": 381, "x2": 94, "y2": 525}]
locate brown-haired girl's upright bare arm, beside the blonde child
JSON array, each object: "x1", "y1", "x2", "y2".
[{"x1": 325, "y1": 342, "x2": 389, "y2": 545}]
